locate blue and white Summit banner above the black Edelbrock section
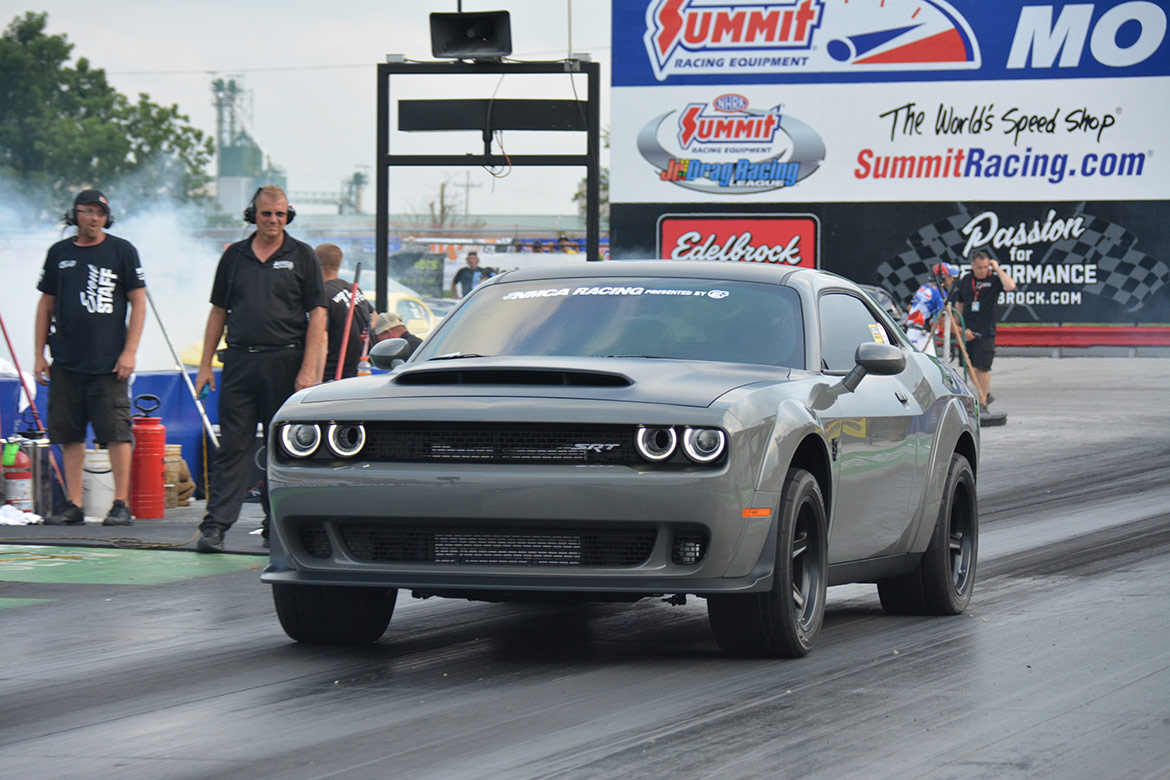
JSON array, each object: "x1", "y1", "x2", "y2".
[{"x1": 611, "y1": 0, "x2": 1170, "y2": 202}]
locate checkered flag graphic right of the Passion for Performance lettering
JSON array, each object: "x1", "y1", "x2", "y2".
[{"x1": 1044, "y1": 214, "x2": 1170, "y2": 311}]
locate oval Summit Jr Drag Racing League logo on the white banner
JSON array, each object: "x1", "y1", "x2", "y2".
[{"x1": 638, "y1": 92, "x2": 825, "y2": 195}]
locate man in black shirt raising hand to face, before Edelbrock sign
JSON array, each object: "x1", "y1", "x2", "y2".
[{"x1": 950, "y1": 249, "x2": 1016, "y2": 406}]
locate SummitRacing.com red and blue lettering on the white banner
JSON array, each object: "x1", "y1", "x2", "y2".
[{"x1": 853, "y1": 146, "x2": 1145, "y2": 184}]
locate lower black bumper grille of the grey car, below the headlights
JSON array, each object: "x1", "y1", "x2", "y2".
[{"x1": 340, "y1": 523, "x2": 658, "y2": 566}]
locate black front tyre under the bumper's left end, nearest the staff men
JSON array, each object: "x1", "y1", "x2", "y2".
[{"x1": 273, "y1": 585, "x2": 398, "y2": 644}]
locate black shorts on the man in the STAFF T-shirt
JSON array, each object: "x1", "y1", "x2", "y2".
[{"x1": 49, "y1": 363, "x2": 132, "y2": 444}]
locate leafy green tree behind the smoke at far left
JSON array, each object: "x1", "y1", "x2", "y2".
[{"x1": 0, "y1": 12, "x2": 214, "y2": 216}]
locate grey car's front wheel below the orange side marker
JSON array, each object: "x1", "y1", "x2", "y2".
[{"x1": 707, "y1": 469, "x2": 828, "y2": 658}]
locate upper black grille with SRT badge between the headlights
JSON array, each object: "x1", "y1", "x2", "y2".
[{"x1": 363, "y1": 422, "x2": 641, "y2": 464}]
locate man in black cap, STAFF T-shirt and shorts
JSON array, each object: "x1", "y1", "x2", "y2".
[{"x1": 33, "y1": 189, "x2": 146, "y2": 525}]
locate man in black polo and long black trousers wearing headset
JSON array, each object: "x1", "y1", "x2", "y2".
[{"x1": 195, "y1": 185, "x2": 325, "y2": 552}]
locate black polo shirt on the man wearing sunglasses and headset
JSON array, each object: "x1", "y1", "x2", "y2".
[{"x1": 212, "y1": 233, "x2": 325, "y2": 346}]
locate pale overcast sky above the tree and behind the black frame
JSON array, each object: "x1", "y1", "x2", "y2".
[{"x1": 11, "y1": 0, "x2": 611, "y2": 214}]
